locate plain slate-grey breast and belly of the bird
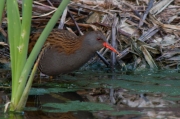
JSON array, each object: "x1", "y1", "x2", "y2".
[{"x1": 39, "y1": 48, "x2": 94, "y2": 76}]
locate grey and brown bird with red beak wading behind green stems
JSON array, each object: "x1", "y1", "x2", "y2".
[{"x1": 28, "y1": 29, "x2": 118, "y2": 76}]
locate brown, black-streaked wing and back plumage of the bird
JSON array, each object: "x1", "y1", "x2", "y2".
[{"x1": 28, "y1": 29, "x2": 82, "y2": 54}]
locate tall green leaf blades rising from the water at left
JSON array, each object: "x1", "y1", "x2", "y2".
[{"x1": 0, "y1": 0, "x2": 70, "y2": 111}]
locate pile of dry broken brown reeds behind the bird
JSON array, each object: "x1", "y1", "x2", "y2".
[{"x1": 0, "y1": 0, "x2": 180, "y2": 69}]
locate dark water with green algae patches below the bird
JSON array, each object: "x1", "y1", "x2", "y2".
[{"x1": 0, "y1": 70, "x2": 180, "y2": 119}]
